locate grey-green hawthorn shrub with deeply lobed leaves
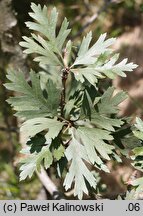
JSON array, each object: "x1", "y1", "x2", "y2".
[{"x1": 5, "y1": 3, "x2": 143, "y2": 199}]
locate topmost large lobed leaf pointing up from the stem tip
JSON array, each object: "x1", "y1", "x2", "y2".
[{"x1": 20, "y1": 3, "x2": 70, "y2": 66}]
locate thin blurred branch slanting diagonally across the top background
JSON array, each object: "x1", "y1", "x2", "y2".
[{"x1": 71, "y1": 0, "x2": 112, "y2": 40}]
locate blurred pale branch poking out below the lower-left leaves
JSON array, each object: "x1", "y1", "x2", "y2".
[{"x1": 37, "y1": 167, "x2": 63, "y2": 200}]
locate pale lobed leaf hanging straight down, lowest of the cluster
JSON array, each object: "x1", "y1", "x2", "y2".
[{"x1": 64, "y1": 129, "x2": 96, "y2": 199}]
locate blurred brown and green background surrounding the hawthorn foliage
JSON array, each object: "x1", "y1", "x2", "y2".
[{"x1": 0, "y1": 0, "x2": 143, "y2": 199}]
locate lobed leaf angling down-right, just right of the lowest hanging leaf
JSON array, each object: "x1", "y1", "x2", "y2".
[{"x1": 77, "y1": 127, "x2": 114, "y2": 168}]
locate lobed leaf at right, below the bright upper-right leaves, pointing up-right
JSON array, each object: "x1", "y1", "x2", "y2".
[{"x1": 91, "y1": 87, "x2": 126, "y2": 131}]
